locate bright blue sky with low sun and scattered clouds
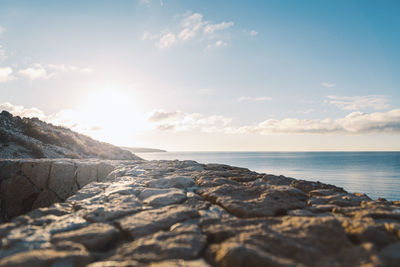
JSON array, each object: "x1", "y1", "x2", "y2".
[{"x1": 0, "y1": 0, "x2": 400, "y2": 151}]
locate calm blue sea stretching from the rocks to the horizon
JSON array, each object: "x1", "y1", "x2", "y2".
[{"x1": 137, "y1": 152, "x2": 400, "y2": 200}]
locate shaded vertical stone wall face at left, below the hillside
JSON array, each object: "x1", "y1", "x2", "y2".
[{"x1": 0, "y1": 159, "x2": 134, "y2": 221}]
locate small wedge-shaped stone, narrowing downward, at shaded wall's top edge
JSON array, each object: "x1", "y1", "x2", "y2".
[{"x1": 21, "y1": 161, "x2": 51, "y2": 189}]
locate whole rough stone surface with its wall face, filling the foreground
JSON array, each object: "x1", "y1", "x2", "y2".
[{"x1": 0, "y1": 159, "x2": 400, "y2": 267}]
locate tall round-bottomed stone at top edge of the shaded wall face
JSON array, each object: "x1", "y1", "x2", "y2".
[{"x1": 49, "y1": 161, "x2": 78, "y2": 199}]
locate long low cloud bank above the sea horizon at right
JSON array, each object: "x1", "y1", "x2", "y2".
[{"x1": 234, "y1": 109, "x2": 400, "y2": 135}]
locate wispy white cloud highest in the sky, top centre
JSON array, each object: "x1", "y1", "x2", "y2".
[{"x1": 148, "y1": 12, "x2": 234, "y2": 49}]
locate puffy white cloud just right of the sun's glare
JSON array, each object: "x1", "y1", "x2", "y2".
[{"x1": 149, "y1": 110, "x2": 232, "y2": 132}]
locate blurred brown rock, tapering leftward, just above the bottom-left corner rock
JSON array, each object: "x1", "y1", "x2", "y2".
[{"x1": 51, "y1": 223, "x2": 119, "y2": 250}]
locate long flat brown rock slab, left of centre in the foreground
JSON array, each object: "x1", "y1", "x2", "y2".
[{"x1": 118, "y1": 205, "x2": 199, "y2": 238}]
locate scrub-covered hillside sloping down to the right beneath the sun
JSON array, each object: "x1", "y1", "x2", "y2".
[{"x1": 0, "y1": 111, "x2": 139, "y2": 160}]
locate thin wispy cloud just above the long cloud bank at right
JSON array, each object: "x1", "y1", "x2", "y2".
[{"x1": 326, "y1": 95, "x2": 390, "y2": 110}]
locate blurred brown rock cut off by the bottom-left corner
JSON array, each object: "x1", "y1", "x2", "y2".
[{"x1": 0, "y1": 249, "x2": 91, "y2": 267}]
